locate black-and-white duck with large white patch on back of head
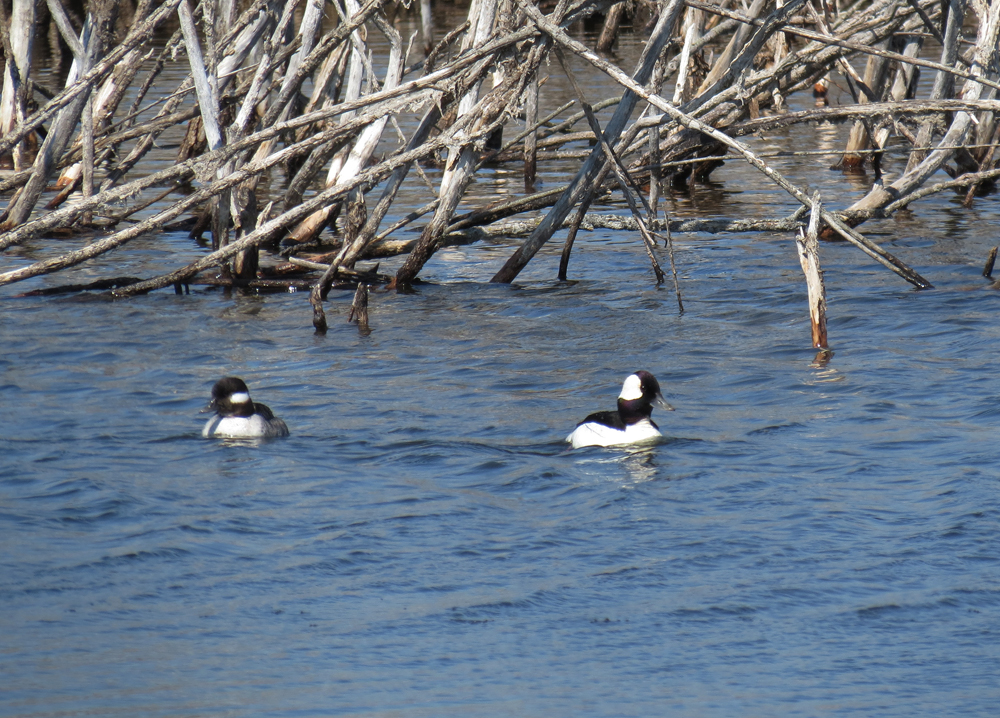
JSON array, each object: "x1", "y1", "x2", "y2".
[{"x1": 566, "y1": 371, "x2": 674, "y2": 449}]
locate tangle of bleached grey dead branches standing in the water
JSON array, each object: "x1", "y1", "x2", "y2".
[{"x1": 0, "y1": 0, "x2": 1000, "y2": 341}]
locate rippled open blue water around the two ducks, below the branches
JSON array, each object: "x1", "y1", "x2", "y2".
[{"x1": 0, "y1": 202, "x2": 1000, "y2": 716}]
